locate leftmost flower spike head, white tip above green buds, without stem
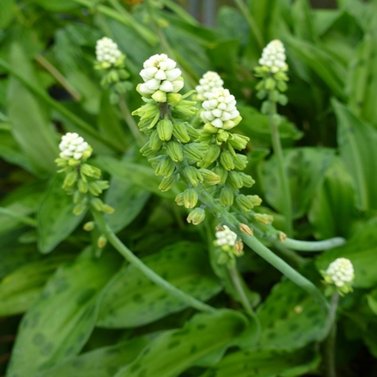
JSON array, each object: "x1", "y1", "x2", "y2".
[{"x1": 55, "y1": 132, "x2": 113, "y2": 215}]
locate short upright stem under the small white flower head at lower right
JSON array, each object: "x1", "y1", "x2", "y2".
[{"x1": 324, "y1": 293, "x2": 339, "y2": 377}]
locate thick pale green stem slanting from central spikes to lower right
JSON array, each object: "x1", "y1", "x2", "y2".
[{"x1": 200, "y1": 190, "x2": 328, "y2": 310}]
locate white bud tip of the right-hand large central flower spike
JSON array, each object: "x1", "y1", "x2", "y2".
[{"x1": 200, "y1": 87, "x2": 241, "y2": 130}]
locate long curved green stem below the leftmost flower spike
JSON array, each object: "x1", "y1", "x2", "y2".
[{"x1": 93, "y1": 212, "x2": 215, "y2": 312}]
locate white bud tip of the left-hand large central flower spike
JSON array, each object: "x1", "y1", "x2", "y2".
[{"x1": 138, "y1": 54, "x2": 184, "y2": 96}]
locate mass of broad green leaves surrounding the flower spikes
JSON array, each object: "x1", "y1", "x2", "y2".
[{"x1": 0, "y1": 0, "x2": 377, "y2": 377}]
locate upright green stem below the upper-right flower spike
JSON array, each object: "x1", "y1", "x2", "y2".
[{"x1": 269, "y1": 102, "x2": 293, "y2": 235}]
